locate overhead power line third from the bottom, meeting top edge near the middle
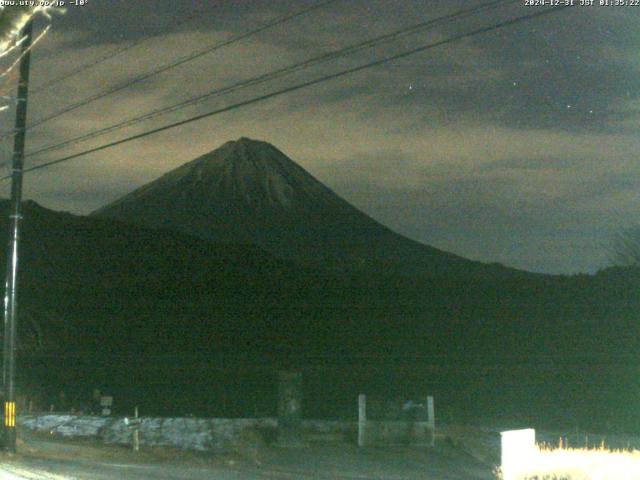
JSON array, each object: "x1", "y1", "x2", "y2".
[{"x1": 0, "y1": 0, "x2": 338, "y2": 140}]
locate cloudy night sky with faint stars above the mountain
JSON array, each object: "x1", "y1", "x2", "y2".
[{"x1": 0, "y1": 0, "x2": 640, "y2": 273}]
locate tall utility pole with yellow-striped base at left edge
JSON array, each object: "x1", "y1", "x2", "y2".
[{"x1": 2, "y1": 20, "x2": 33, "y2": 452}]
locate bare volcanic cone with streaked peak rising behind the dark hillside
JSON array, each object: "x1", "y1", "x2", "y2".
[{"x1": 92, "y1": 138, "x2": 514, "y2": 276}]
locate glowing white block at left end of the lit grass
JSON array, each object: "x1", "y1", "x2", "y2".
[{"x1": 500, "y1": 428, "x2": 538, "y2": 480}]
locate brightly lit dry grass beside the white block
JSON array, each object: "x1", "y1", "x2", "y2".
[{"x1": 497, "y1": 443, "x2": 640, "y2": 480}]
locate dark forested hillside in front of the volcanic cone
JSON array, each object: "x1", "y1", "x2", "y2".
[{"x1": 0, "y1": 198, "x2": 640, "y2": 423}]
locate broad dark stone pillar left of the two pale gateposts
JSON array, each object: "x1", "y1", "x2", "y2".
[{"x1": 278, "y1": 371, "x2": 304, "y2": 447}]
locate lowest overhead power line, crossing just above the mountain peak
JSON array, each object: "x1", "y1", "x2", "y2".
[{"x1": 0, "y1": 5, "x2": 570, "y2": 180}]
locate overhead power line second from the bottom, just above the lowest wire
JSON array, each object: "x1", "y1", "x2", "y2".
[{"x1": 27, "y1": 0, "x2": 513, "y2": 157}]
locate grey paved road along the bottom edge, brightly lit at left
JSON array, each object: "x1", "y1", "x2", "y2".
[{"x1": 0, "y1": 448, "x2": 495, "y2": 480}]
